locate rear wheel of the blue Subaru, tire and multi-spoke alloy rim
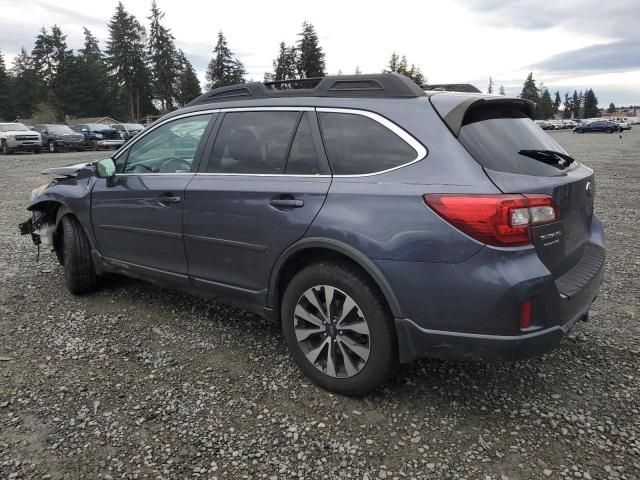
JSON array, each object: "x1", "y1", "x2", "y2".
[{"x1": 281, "y1": 263, "x2": 398, "y2": 396}]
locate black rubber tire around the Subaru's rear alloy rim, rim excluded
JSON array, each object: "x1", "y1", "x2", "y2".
[{"x1": 281, "y1": 262, "x2": 398, "y2": 396}]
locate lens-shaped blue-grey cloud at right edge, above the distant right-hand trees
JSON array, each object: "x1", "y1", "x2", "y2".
[{"x1": 533, "y1": 39, "x2": 640, "y2": 73}]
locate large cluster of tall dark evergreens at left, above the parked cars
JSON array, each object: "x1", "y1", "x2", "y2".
[{"x1": 0, "y1": 0, "x2": 201, "y2": 121}]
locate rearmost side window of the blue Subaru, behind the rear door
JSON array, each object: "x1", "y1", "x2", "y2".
[{"x1": 318, "y1": 112, "x2": 418, "y2": 175}]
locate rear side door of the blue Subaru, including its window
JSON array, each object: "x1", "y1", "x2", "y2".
[{"x1": 184, "y1": 108, "x2": 331, "y2": 303}]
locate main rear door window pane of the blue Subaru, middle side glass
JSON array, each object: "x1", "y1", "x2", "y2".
[{"x1": 207, "y1": 111, "x2": 300, "y2": 174}]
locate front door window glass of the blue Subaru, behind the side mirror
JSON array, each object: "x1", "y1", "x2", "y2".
[{"x1": 116, "y1": 114, "x2": 212, "y2": 174}]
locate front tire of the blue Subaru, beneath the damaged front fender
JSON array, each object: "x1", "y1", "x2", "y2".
[{"x1": 61, "y1": 215, "x2": 98, "y2": 295}]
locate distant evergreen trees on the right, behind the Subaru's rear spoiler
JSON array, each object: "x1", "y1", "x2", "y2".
[{"x1": 520, "y1": 73, "x2": 600, "y2": 120}]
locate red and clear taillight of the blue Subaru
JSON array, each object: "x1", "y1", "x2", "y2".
[{"x1": 424, "y1": 194, "x2": 558, "y2": 247}]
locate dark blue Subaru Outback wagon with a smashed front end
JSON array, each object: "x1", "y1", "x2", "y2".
[{"x1": 21, "y1": 74, "x2": 605, "y2": 395}]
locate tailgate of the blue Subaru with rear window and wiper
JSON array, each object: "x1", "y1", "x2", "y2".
[{"x1": 450, "y1": 101, "x2": 594, "y2": 277}]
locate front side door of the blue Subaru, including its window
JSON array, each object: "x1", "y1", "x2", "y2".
[{"x1": 91, "y1": 114, "x2": 212, "y2": 282}]
